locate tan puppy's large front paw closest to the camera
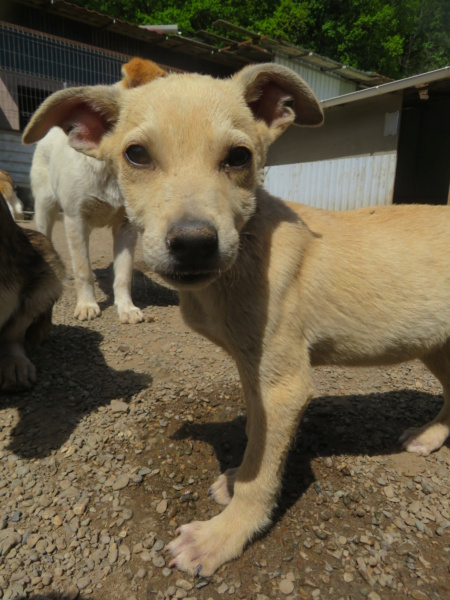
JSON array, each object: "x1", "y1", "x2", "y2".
[{"x1": 167, "y1": 513, "x2": 245, "y2": 577}]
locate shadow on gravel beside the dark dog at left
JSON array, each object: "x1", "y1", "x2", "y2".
[{"x1": 0, "y1": 325, "x2": 151, "y2": 458}]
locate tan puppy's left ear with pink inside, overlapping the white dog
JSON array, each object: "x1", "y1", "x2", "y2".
[{"x1": 22, "y1": 86, "x2": 121, "y2": 157}]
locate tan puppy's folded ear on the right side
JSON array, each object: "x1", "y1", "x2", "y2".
[{"x1": 234, "y1": 63, "x2": 323, "y2": 138}]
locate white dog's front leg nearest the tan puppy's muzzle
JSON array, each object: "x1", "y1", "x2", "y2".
[{"x1": 113, "y1": 219, "x2": 144, "y2": 323}]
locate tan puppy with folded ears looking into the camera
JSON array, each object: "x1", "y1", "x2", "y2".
[{"x1": 24, "y1": 64, "x2": 450, "y2": 575}]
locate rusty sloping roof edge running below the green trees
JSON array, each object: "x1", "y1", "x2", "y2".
[{"x1": 15, "y1": 0, "x2": 390, "y2": 87}]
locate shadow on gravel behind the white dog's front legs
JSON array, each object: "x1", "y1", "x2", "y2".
[{"x1": 94, "y1": 261, "x2": 178, "y2": 310}]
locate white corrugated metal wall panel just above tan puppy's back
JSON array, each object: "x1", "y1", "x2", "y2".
[{"x1": 264, "y1": 152, "x2": 397, "y2": 210}]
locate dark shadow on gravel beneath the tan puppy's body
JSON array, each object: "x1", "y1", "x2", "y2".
[{"x1": 173, "y1": 390, "x2": 449, "y2": 521}]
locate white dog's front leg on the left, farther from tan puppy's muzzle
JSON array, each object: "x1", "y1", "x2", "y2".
[{"x1": 64, "y1": 213, "x2": 100, "y2": 321}]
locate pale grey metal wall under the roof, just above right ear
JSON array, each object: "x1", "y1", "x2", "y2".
[{"x1": 274, "y1": 53, "x2": 358, "y2": 100}]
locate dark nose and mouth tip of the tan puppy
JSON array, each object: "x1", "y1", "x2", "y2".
[{"x1": 165, "y1": 220, "x2": 220, "y2": 283}]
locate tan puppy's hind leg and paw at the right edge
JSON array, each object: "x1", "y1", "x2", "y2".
[{"x1": 400, "y1": 342, "x2": 450, "y2": 456}]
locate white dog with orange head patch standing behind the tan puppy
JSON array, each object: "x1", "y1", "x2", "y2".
[{"x1": 31, "y1": 58, "x2": 166, "y2": 323}]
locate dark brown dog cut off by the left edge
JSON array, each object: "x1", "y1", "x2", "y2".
[{"x1": 0, "y1": 195, "x2": 64, "y2": 391}]
